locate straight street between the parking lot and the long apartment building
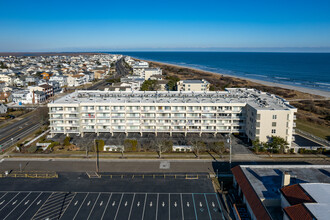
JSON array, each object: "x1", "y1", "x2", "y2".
[{"x1": 0, "y1": 158, "x2": 330, "y2": 173}]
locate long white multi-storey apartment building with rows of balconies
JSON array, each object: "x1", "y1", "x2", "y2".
[{"x1": 48, "y1": 88, "x2": 297, "y2": 147}]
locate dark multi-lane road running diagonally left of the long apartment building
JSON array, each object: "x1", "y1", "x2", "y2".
[{"x1": 0, "y1": 107, "x2": 48, "y2": 150}]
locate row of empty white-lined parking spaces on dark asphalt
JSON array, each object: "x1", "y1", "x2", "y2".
[{"x1": 0, "y1": 191, "x2": 224, "y2": 220}]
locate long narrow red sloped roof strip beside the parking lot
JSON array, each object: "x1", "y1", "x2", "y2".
[{"x1": 231, "y1": 166, "x2": 272, "y2": 220}]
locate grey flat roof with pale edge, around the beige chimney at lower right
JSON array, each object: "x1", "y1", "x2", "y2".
[{"x1": 241, "y1": 165, "x2": 330, "y2": 199}]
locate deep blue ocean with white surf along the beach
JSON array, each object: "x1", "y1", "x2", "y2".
[{"x1": 111, "y1": 52, "x2": 330, "y2": 91}]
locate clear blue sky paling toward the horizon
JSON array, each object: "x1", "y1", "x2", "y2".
[{"x1": 0, "y1": 0, "x2": 330, "y2": 52}]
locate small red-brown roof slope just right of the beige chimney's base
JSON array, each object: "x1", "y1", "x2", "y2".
[{"x1": 281, "y1": 184, "x2": 315, "y2": 205}]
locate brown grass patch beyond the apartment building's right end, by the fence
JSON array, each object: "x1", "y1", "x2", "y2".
[{"x1": 296, "y1": 119, "x2": 330, "y2": 140}]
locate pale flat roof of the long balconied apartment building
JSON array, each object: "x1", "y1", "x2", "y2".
[{"x1": 50, "y1": 88, "x2": 295, "y2": 110}]
